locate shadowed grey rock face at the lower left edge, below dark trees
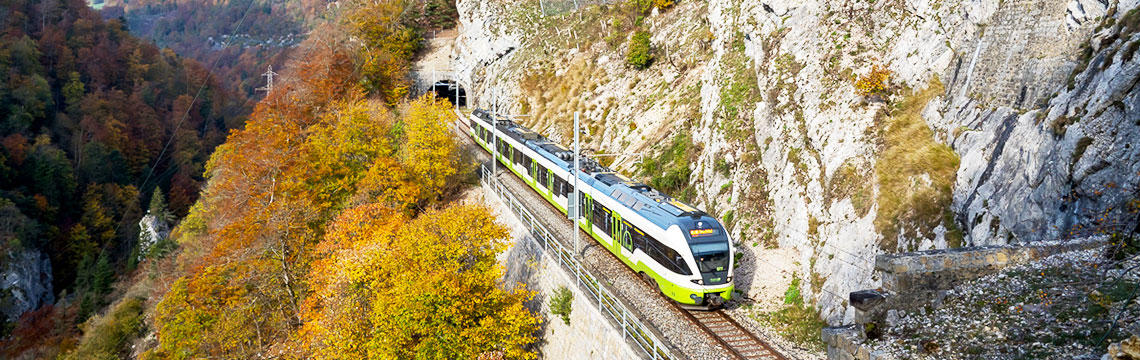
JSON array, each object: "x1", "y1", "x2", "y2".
[{"x1": 0, "y1": 249, "x2": 56, "y2": 321}]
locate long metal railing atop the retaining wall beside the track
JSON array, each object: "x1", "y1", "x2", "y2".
[{"x1": 480, "y1": 166, "x2": 676, "y2": 359}]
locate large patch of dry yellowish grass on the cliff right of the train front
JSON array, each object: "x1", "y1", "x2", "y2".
[{"x1": 874, "y1": 79, "x2": 961, "y2": 251}]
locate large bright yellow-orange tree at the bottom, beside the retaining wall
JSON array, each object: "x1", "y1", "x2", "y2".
[{"x1": 301, "y1": 204, "x2": 538, "y2": 359}]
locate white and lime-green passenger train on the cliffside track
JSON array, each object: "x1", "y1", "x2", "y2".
[{"x1": 469, "y1": 109, "x2": 735, "y2": 309}]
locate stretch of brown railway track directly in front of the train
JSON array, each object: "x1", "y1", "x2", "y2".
[{"x1": 674, "y1": 304, "x2": 785, "y2": 360}]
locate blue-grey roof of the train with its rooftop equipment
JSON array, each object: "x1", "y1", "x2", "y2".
[{"x1": 473, "y1": 109, "x2": 723, "y2": 235}]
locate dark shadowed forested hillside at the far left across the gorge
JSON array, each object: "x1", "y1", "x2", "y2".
[{"x1": 0, "y1": 0, "x2": 243, "y2": 351}]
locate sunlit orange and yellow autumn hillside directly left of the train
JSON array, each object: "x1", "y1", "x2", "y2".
[{"x1": 5, "y1": 1, "x2": 538, "y2": 359}]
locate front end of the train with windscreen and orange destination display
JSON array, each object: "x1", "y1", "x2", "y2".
[{"x1": 683, "y1": 215, "x2": 734, "y2": 308}]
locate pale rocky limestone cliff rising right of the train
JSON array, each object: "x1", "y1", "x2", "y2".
[{"x1": 454, "y1": 0, "x2": 1140, "y2": 324}]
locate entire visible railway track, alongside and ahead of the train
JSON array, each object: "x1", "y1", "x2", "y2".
[{"x1": 453, "y1": 110, "x2": 787, "y2": 360}]
